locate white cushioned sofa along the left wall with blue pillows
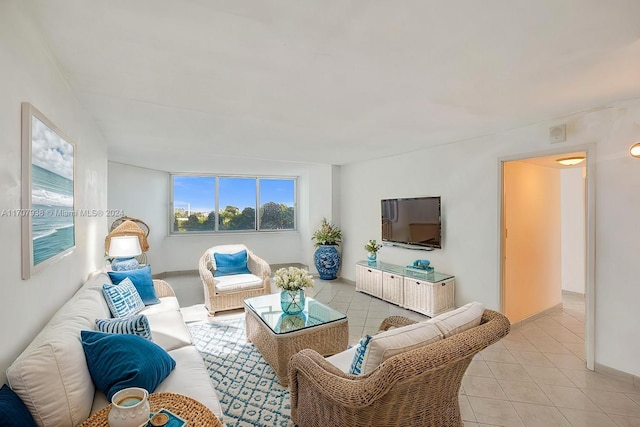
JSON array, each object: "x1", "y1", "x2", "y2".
[{"x1": 7, "y1": 272, "x2": 222, "y2": 427}]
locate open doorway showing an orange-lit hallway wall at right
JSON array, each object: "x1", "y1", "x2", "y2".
[{"x1": 500, "y1": 150, "x2": 594, "y2": 369}]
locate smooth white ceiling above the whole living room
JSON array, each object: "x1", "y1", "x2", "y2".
[{"x1": 28, "y1": 0, "x2": 640, "y2": 169}]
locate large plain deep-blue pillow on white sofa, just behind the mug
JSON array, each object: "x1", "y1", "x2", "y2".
[{"x1": 80, "y1": 331, "x2": 176, "y2": 401}]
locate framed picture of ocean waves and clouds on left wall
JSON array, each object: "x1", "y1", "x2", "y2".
[{"x1": 20, "y1": 102, "x2": 76, "y2": 279}]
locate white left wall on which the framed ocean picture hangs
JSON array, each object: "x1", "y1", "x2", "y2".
[{"x1": 0, "y1": 0, "x2": 107, "y2": 383}]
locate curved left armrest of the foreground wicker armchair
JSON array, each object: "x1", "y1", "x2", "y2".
[{"x1": 289, "y1": 349, "x2": 392, "y2": 408}]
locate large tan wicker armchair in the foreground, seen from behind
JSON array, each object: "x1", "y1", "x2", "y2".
[{"x1": 289, "y1": 310, "x2": 510, "y2": 427}]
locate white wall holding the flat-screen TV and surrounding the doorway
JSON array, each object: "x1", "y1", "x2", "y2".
[{"x1": 340, "y1": 100, "x2": 640, "y2": 375}]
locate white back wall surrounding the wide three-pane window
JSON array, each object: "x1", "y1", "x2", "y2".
[{"x1": 109, "y1": 160, "x2": 339, "y2": 274}]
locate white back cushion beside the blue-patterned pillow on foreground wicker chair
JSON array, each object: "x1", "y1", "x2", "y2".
[{"x1": 361, "y1": 322, "x2": 442, "y2": 374}]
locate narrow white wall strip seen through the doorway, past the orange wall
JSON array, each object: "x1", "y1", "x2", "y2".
[{"x1": 560, "y1": 167, "x2": 586, "y2": 294}]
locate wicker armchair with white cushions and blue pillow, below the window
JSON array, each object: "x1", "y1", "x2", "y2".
[{"x1": 198, "y1": 245, "x2": 271, "y2": 316}]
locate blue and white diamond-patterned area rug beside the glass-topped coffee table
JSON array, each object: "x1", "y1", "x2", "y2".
[{"x1": 189, "y1": 316, "x2": 293, "y2": 427}]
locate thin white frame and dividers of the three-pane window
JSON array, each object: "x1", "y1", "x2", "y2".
[{"x1": 168, "y1": 172, "x2": 298, "y2": 236}]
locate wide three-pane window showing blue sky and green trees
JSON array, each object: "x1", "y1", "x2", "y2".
[{"x1": 170, "y1": 175, "x2": 296, "y2": 234}]
